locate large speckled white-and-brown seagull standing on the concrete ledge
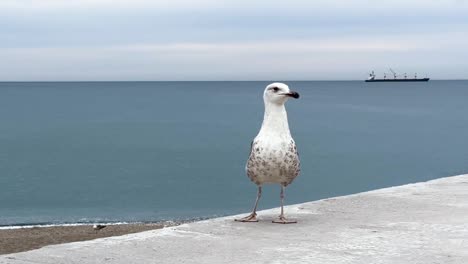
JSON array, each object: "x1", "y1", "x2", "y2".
[{"x1": 235, "y1": 83, "x2": 300, "y2": 224}]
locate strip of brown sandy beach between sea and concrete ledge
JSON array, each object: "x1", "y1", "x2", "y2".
[{"x1": 0, "y1": 224, "x2": 167, "y2": 254}]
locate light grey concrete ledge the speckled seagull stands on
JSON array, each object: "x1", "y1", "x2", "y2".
[{"x1": 0, "y1": 175, "x2": 468, "y2": 264}]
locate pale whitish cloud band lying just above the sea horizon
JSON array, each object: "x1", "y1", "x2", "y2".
[{"x1": 0, "y1": 32, "x2": 468, "y2": 80}]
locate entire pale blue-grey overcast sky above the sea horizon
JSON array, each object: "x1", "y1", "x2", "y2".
[{"x1": 0, "y1": 0, "x2": 468, "y2": 81}]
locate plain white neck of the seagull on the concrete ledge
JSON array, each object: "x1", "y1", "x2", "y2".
[{"x1": 259, "y1": 102, "x2": 291, "y2": 138}]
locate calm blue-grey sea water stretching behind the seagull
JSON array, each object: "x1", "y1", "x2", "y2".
[{"x1": 0, "y1": 81, "x2": 468, "y2": 225}]
